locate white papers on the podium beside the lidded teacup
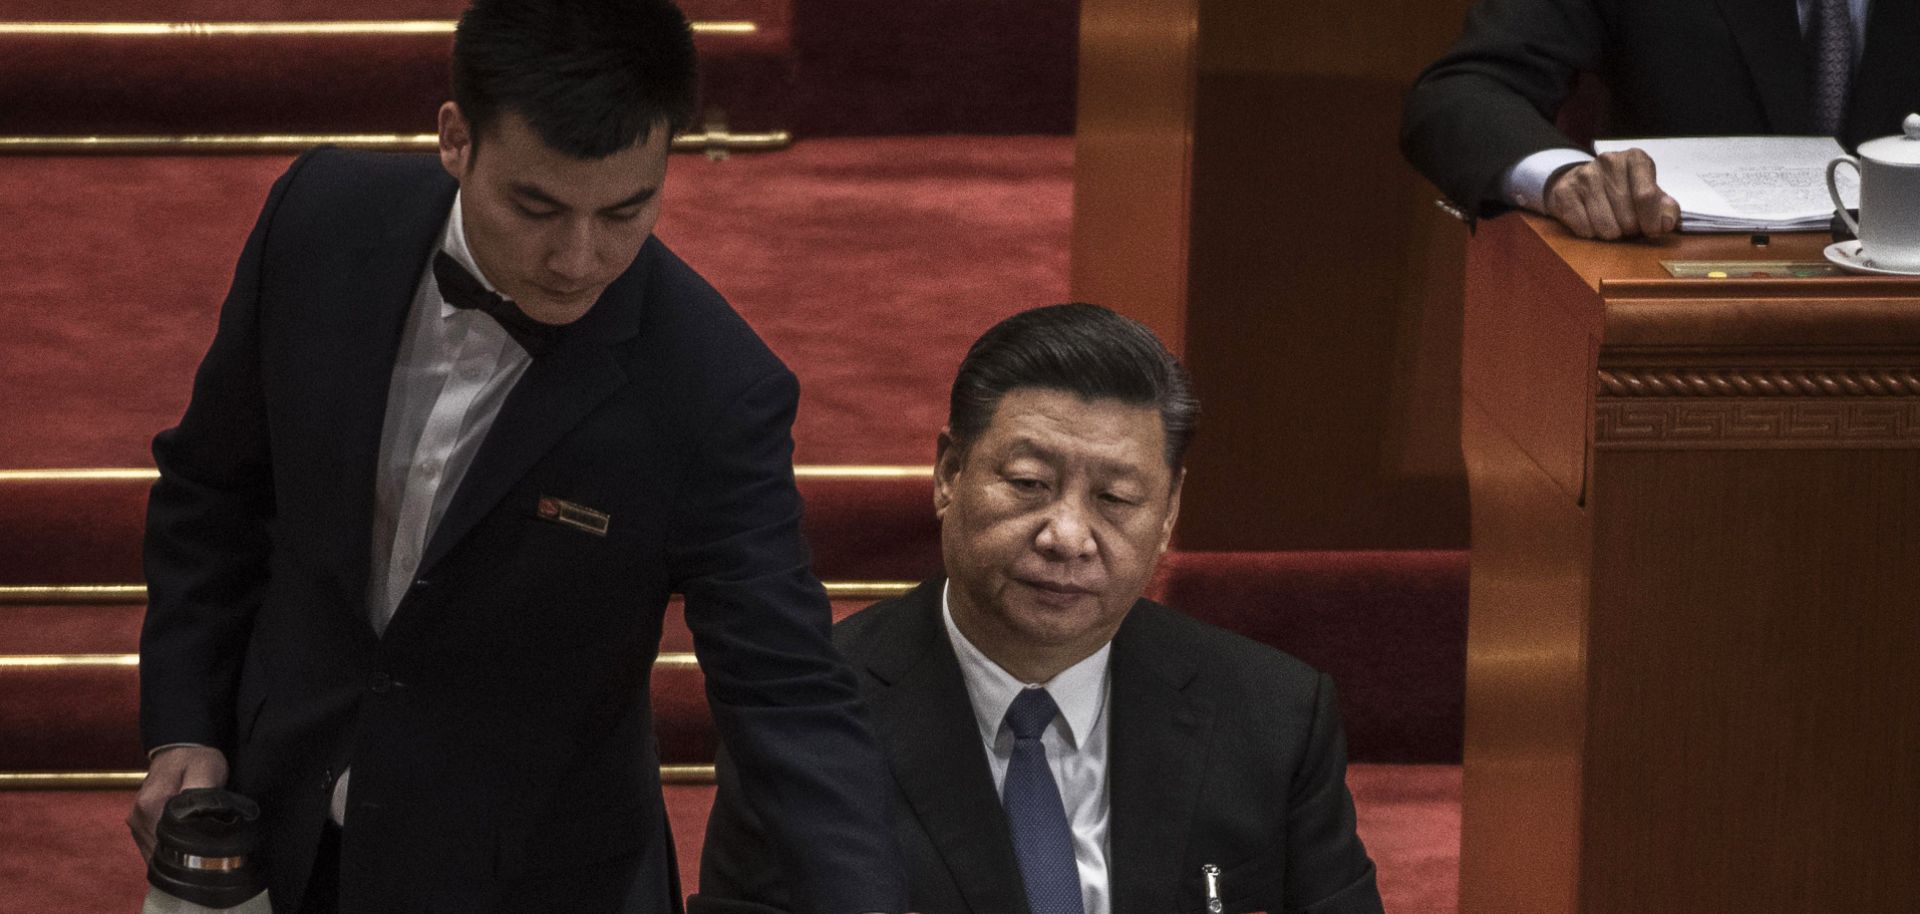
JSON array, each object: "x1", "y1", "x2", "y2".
[{"x1": 1594, "y1": 136, "x2": 1860, "y2": 232}]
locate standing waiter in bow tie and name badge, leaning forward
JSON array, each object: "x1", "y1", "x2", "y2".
[{"x1": 129, "y1": 0, "x2": 904, "y2": 914}]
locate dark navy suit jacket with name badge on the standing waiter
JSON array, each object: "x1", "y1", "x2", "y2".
[{"x1": 140, "y1": 150, "x2": 902, "y2": 914}]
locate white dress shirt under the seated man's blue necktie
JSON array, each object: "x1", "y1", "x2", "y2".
[{"x1": 941, "y1": 582, "x2": 1114, "y2": 914}]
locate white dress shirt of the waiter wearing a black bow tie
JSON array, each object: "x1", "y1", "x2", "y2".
[{"x1": 330, "y1": 194, "x2": 534, "y2": 824}]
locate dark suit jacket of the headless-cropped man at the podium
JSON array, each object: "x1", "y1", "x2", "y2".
[{"x1": 1400, "y1": 0, "x2": 1920, "y2": 215}]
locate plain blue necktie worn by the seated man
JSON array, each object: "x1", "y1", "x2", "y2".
[{"x1": 1000, "y1": 689, "x2": 1083, "y2": 914}]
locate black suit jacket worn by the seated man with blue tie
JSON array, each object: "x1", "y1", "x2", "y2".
[{"x1": 687, "y1": 580, "x2": 1380, "y2": 914}]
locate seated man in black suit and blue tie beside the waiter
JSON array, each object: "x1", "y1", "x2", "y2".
[{"x1": 689, "y1": 305, "x2": 1380, "y2": 914}]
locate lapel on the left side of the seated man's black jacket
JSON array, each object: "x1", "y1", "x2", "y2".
[{"x1": 868, "y1": 582, "x2": 1027, "y2": 914}]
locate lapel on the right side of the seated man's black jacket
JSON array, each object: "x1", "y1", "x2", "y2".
[{"x1": 1106, "y1": 601, "x2": 1212, "y2": 914}]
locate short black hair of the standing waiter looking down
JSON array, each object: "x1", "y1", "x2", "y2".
[{"x1": 453, "y1": 0, "x2": 699, "y2": 159}]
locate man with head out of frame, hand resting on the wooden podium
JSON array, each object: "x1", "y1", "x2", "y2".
[{"x1": 1400, "y1": 0, "x2": 1920, "y2": 240}]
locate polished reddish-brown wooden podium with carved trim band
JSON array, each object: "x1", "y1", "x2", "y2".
[{"x1": 1461, "y1": 215, "x2": 1920, "y2": 914}]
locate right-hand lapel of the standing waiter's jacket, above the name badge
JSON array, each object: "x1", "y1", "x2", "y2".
[{"x1": 420, "y1": 240, "x2": 659, "y2": 572}]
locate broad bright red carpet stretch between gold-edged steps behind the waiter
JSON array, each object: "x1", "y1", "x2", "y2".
[{"x1": 0, "y1": 136, "x2": 1073, "y2": 469}]
